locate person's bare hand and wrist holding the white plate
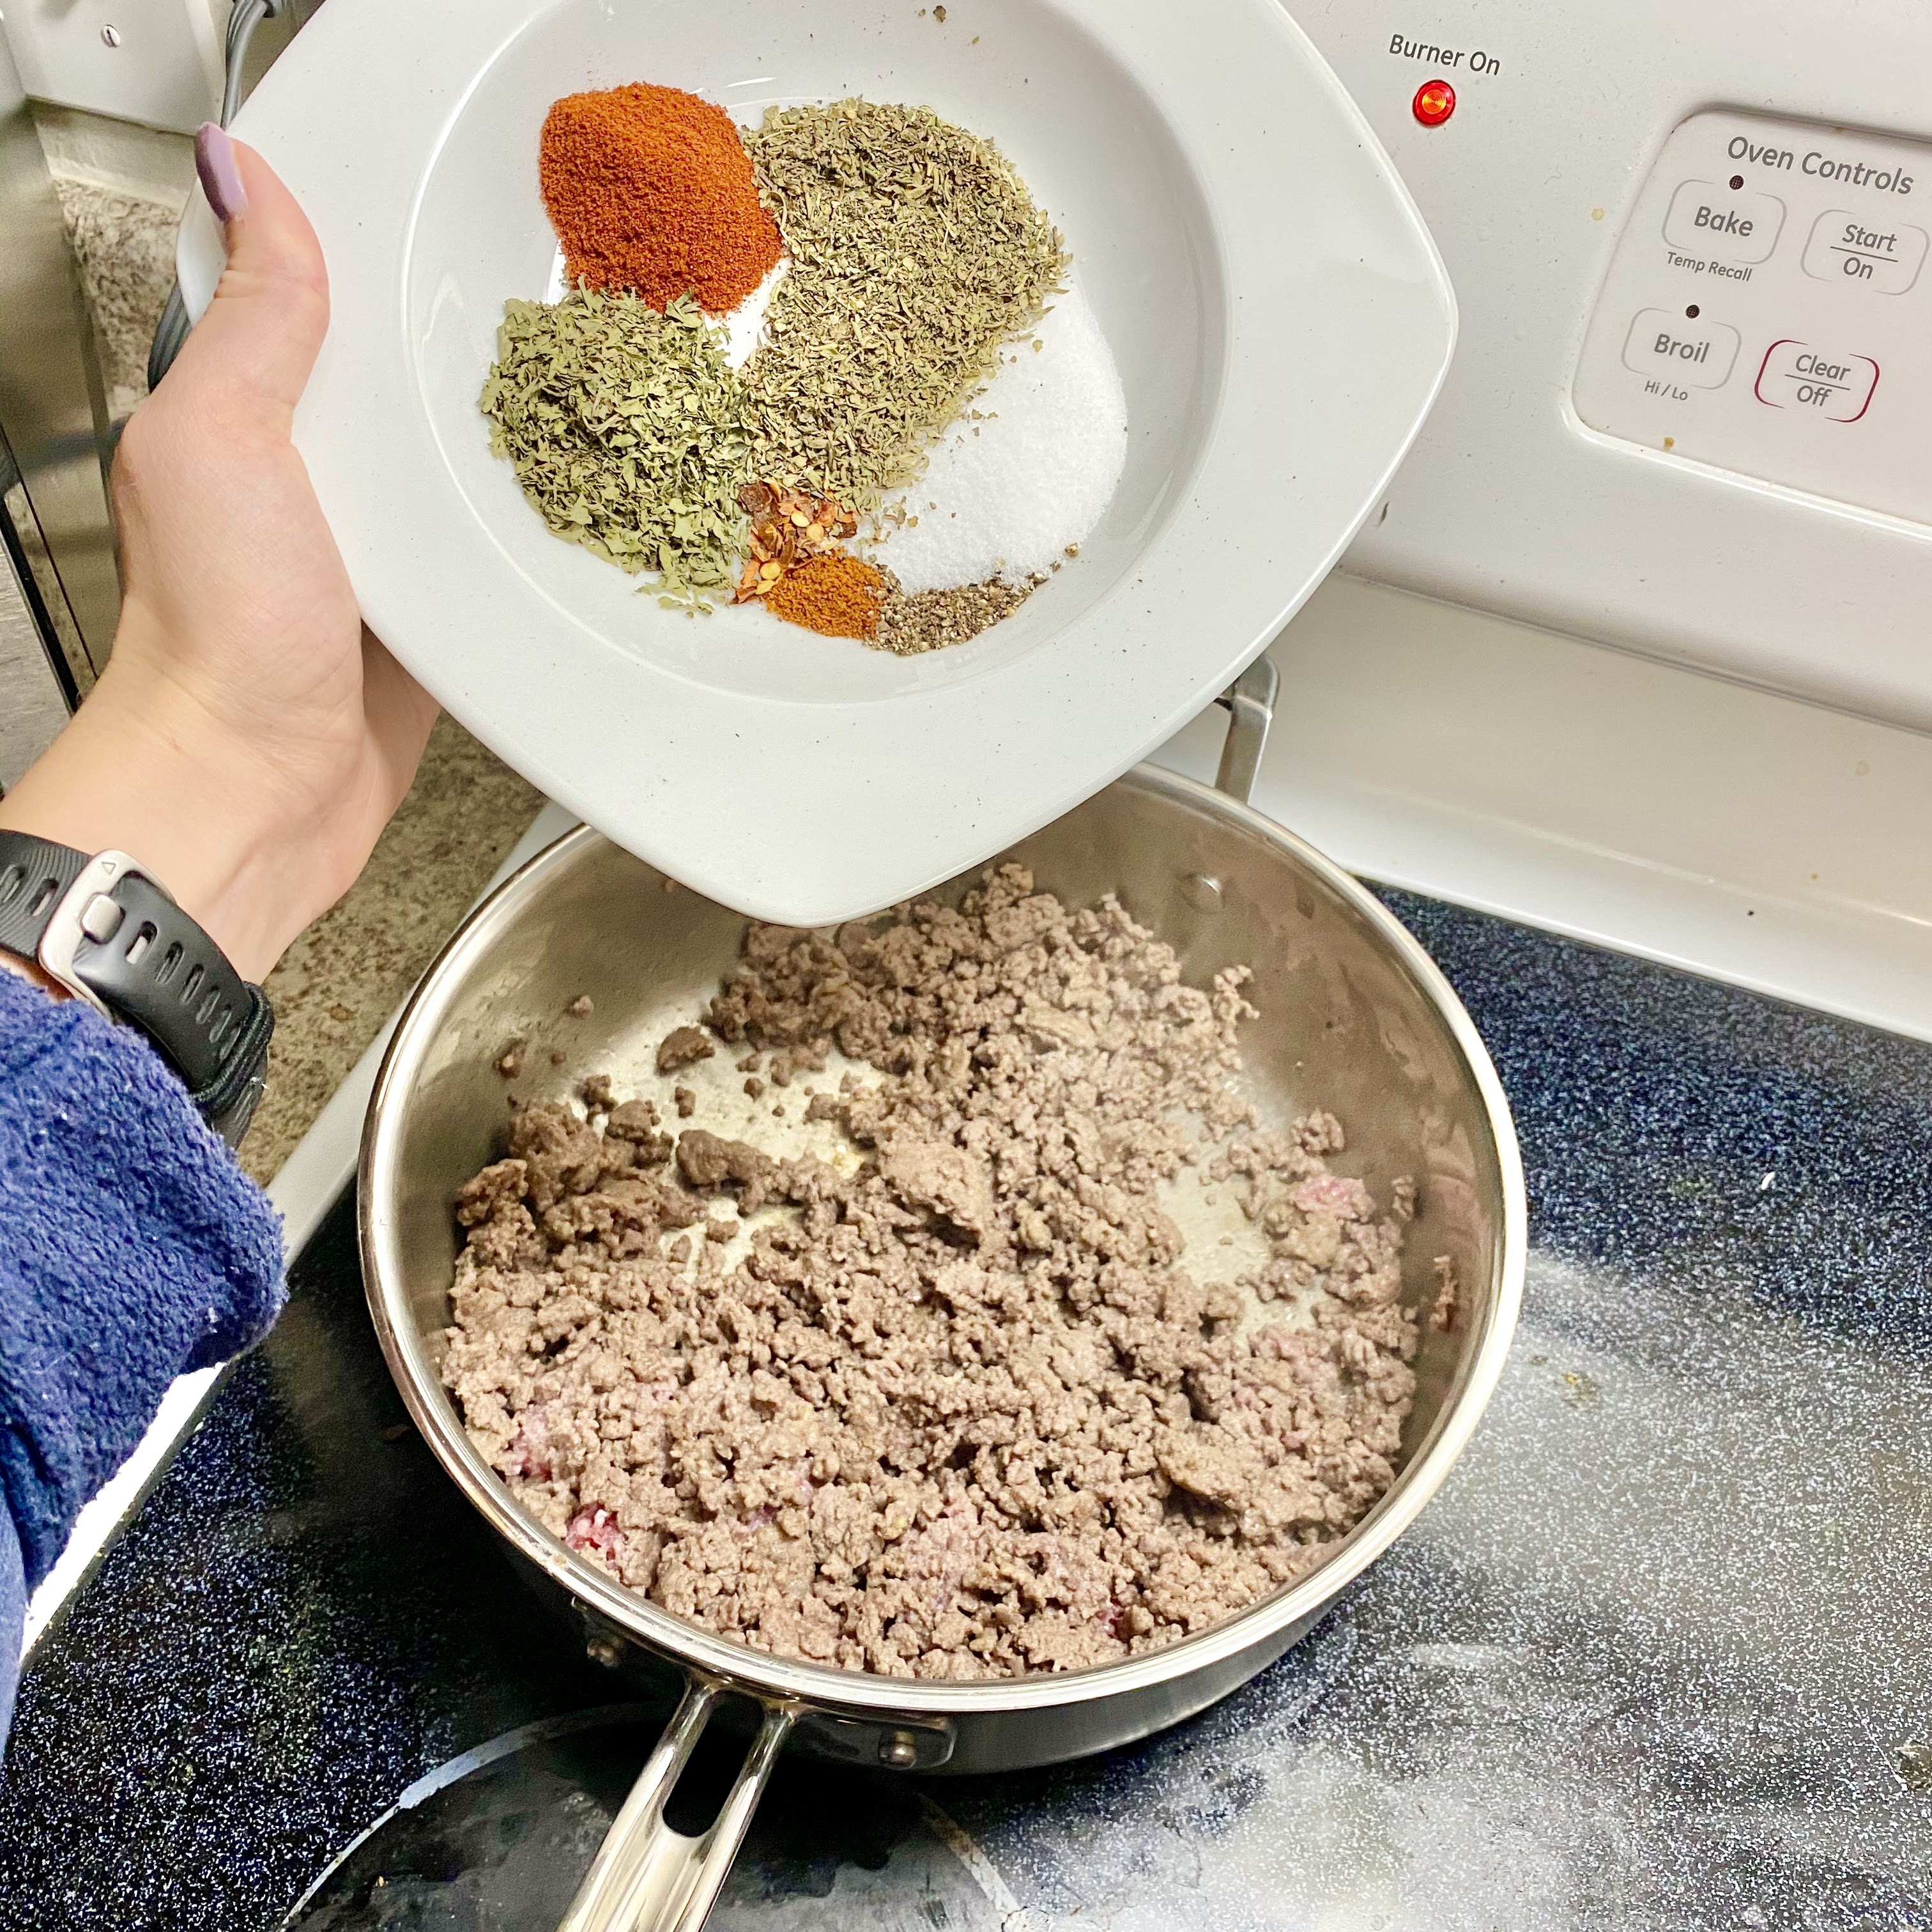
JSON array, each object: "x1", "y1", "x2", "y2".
[{"x1": 0, "y1": 128, "x2": 436, "y2": 979}]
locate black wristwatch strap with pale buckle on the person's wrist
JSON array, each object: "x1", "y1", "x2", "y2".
[{"x1": 0, "y1": 831, "x2": 274, "y2": 1147}]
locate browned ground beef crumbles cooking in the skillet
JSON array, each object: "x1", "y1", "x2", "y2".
[{"x1": 442, "y1": 866, "x2": 1416, "y2": 1677}]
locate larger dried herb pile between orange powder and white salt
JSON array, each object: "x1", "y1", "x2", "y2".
[{"x1": 744, "y1": 100, "x2": 1066, "y2": 506}]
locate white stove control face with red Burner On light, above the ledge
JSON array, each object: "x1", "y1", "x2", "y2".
[{"x1": 1250, "y1": 0, "x2": 1932, "y2": 732}]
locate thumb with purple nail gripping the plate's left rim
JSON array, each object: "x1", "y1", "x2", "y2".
[{"x1": 170, "y1": 122, "x2": 328, "y2": 417}]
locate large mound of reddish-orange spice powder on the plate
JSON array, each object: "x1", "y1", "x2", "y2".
[{"x1": 539, "y1": 81, "x2": 785, "y2": 315}]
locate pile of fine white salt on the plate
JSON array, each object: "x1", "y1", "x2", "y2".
[{"x1": 873, "y1": 290, "x2": 1126, "y2": 591}]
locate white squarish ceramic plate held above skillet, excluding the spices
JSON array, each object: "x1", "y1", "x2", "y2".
[{"x1": 180, "y1": 0, "x2": 1455, "y2": 925}]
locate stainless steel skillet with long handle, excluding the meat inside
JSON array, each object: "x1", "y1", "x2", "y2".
[{"x1": 359, "y1": 672, "x2": 1526, "y2": 1932}]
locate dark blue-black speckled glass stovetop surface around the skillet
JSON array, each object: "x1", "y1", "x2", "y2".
[{"x1": 0, "y1": 898, "x2": 1932, "y2": 1932}]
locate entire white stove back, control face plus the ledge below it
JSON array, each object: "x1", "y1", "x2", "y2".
[{"x1": 1190, "y1": 0, "x2": 1932, "y2": 1038}]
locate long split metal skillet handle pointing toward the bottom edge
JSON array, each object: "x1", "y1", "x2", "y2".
[{"x1": 556, "y1": 1677, "x2": 792, "y2": 1932}]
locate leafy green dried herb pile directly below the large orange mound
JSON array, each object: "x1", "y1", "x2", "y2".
[{"x1": 479, "y1": 290, "x2": 751, "y2": 601}]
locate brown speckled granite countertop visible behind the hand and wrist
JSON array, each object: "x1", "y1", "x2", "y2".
[{"x1": 38, "y1": 132, "x2": 543, "y2": 1181}]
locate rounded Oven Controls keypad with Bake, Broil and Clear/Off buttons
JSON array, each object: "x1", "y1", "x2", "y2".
[{"x1": 1573, "y1": 114, "x2": 1932, "y2": 524}]
